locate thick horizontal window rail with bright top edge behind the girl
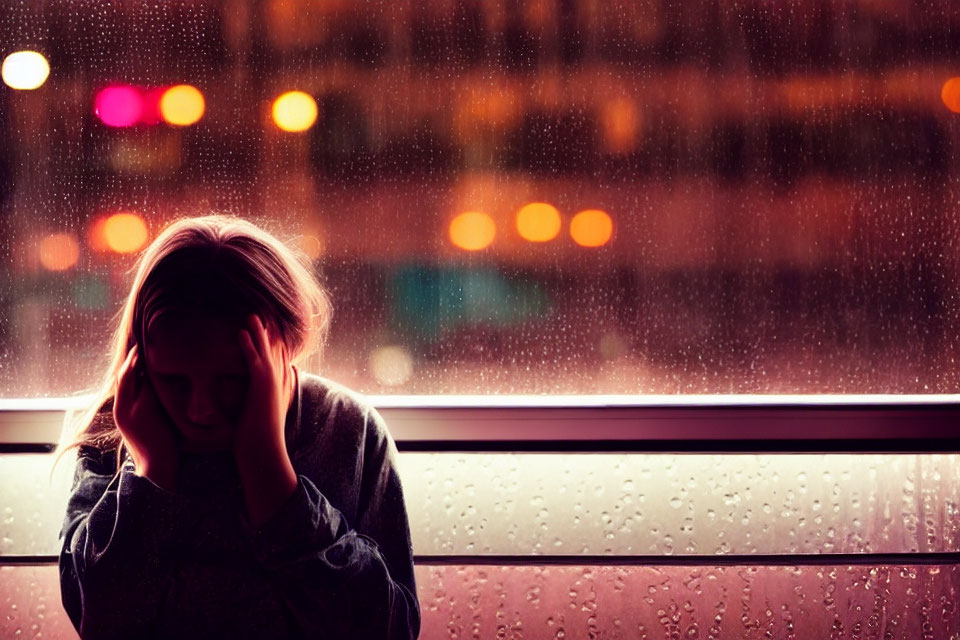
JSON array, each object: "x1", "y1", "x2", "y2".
[{"x1": 0, "y1": 395, "x2": 960, "y2": 453}]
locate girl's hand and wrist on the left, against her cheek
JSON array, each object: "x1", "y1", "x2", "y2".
[{"x1": 113, "y1": 345, "x2": 179, "y2": 492}]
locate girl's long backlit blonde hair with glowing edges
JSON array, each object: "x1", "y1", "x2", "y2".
[{"x1": 56, "y1": 215, "x2": 332, "y2": 470}]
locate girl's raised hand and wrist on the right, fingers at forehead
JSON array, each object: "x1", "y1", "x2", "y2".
[{"x1": 233, "y1": 315, "x2": 297, "y2": 525}]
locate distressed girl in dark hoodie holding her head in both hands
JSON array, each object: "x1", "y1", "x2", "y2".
[{"x1": 60, "y1": 216, "x2": 420, "y2": 639}]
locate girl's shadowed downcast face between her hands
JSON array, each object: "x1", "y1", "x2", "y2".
[{"x1": 146, "y1": 311, "x2": 248, "y2": 453}]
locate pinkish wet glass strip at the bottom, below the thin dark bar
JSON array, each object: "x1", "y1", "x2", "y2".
[{"x1": 7, "y1": 565, "x2": 960, "y2": 640}]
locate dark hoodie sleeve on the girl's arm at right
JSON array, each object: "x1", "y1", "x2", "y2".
[{"x1": 251, "y1": 409, "x2": 420, "y2": 640}]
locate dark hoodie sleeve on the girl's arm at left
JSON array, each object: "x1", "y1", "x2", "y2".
[{"x1": 59, "y1": 452, "x2": 201, "y2": 639}]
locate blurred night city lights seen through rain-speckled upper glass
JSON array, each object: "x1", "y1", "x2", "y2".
[{"x1": 0, "y1": 0, "x2": 960, "y2": 397}]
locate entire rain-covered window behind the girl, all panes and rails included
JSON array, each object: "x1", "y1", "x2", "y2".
[{"x1": 0, "y1": 0, "x2": 960, "y2": 638}]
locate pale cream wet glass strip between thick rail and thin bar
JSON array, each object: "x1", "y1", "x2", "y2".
[{"x1": 7, "y1": 453, "x2": 960, "y2": 556}]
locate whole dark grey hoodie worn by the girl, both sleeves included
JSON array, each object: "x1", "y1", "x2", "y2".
[{"x1": 60, "y1": 372, "x2": 420, "y2": 640}]
